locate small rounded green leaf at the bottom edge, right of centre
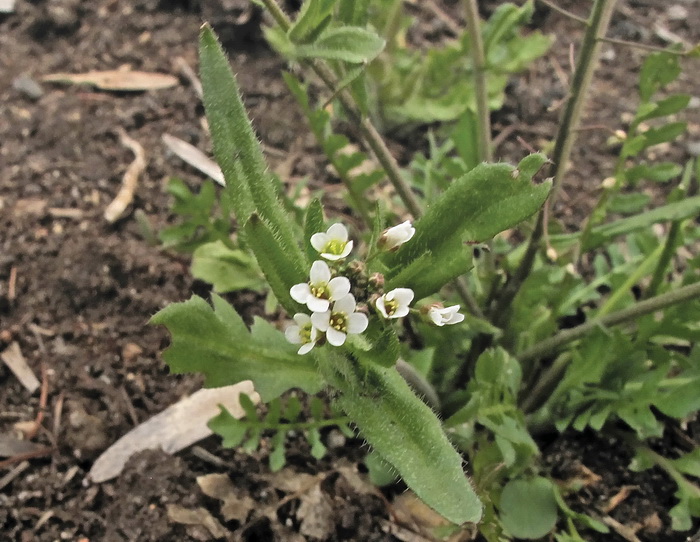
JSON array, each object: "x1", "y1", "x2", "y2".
[{"x1": 499, "y1": 477, "x2": 557, "y2": 540}]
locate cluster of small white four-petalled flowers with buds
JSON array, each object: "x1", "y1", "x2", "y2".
[{"x1": 285, "y1": 221, "x2": 464, "y2": 354}]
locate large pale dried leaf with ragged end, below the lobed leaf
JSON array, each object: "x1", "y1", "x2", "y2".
[{"x1": 88, "y1": 380, "x2": 260, "y2": 483}]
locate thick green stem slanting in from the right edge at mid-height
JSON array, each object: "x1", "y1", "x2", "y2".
[{"x1": 517, "y1": 282, "x2": 700, "y2": 370}]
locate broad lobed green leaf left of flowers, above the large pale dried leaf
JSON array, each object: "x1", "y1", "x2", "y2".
[{"x1": 151, "y1": 295, "x2": 323, "y2": 402}]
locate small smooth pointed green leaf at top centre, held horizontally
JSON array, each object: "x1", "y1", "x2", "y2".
[{"x1": 294, "y1": 26, "x2": 386, "y2": 64}]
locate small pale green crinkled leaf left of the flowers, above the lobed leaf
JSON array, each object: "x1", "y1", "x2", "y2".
[{"x1": 191, "y1": 241, "x2": 266, "y2": 293}]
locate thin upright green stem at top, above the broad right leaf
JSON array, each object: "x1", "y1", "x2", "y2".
[{"x1": 464, "y1": 0, "x2": 492, "y2": 162}]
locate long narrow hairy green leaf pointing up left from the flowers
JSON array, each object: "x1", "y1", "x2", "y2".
[{"x1": 199, "y1": 25, "x2": 305, "y2": 265}]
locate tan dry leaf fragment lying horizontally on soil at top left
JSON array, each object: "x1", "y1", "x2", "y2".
[{"x1": 41, "y1": 70, "x2": 178, "y2": 92}]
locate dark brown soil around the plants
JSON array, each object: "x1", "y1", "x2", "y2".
[{"x1": 0, "y1": 0, "x2": 700, "y2": 542}]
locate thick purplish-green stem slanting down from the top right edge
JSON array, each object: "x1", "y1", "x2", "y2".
[{"x1": 495, "y1": 0, "x2": 615, "y2": 324}]
